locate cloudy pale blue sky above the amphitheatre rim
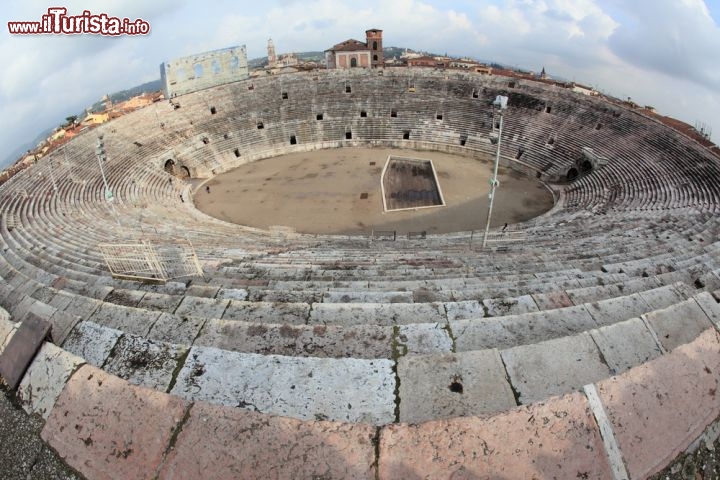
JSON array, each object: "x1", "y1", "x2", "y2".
[{"x1": 0, "y1": 0, "x2": 720, "y2": 166}]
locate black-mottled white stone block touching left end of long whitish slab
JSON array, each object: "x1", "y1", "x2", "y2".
[{"x1": 104, "y1": 334, "x2": 188, "y2": 392}]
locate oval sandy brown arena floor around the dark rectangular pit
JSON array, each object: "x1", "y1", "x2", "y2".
[{"x1": 193, "y1": 148, "x2": 553, "y2": 234}]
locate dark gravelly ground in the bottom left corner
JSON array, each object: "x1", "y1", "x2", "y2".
[{"x1": 0, "y1": 387, "x2": 83, "y2": 480}]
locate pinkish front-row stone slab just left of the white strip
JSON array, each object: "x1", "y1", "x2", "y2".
[{"x1": 379, "y1": 393, "x2": 611, "y2": 480}]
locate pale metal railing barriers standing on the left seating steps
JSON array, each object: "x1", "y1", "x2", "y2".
[{"x1": 98, "y1": 240, "x2": 203, "y2": 283}]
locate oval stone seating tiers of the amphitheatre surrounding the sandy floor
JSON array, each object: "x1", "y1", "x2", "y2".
[{"x1": 0, "y1": 69, "x2": 720, "y2": 479}]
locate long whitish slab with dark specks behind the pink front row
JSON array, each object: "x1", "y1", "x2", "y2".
[{"x1": 171, "y1": 347, "x2": 395, "y2": 425}]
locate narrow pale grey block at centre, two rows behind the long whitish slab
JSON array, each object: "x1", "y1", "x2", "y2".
[{"x1": 310, "y1": 303, "x2": 447, "y2": 326}]
